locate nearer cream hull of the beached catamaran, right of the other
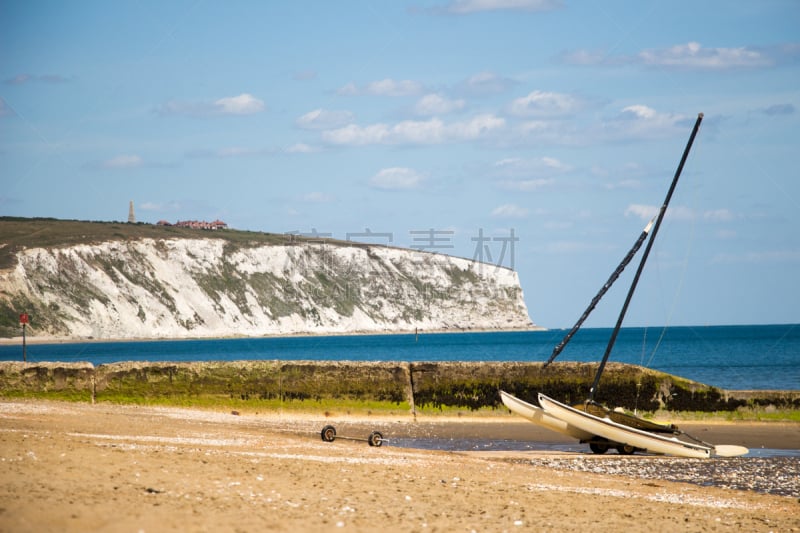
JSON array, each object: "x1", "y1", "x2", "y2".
[{"x1": 539, "y1": 393, "x2": 713, "y2": 459}]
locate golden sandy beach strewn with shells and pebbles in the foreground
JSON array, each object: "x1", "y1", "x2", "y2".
[{"x1": 0, "y1": 401, "x2": 800, "y2": 532}]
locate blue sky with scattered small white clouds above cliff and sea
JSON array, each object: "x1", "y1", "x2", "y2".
[{"x1": 0, "y1": 0, "x2": 800, "y2": 328}]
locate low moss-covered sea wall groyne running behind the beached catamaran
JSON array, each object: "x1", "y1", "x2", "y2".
[{"x1": 0, "y1": 360, "x2": 800, "y2": 413}]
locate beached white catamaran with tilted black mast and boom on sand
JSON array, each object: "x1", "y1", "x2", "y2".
[{"x1": 500, "y1": 113, "x2": 749, "y2": 459}]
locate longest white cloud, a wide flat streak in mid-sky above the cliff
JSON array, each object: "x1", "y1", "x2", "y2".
[{"x1": 322, "y1": 114, "x2": 505, "y2": 145}]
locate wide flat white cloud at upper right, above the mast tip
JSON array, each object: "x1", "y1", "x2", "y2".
[{"x1": 638, "y1": 42, "x2": 774, "y2": 70}]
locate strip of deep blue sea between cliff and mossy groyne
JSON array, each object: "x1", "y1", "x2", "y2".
[{"x1": 0, "y1": 324, "x2": 800, "y2": 390}]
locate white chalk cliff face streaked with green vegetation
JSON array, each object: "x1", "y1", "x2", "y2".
[{"x1": 0, "y1": 239, "x2": 533, "y2": 339}]
